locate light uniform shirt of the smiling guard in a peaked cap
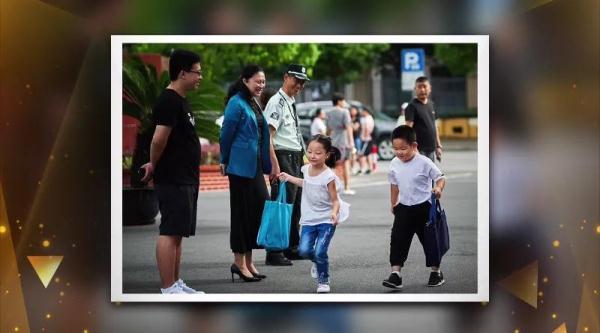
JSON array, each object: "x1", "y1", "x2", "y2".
[{"x1": 264, "y1": 89, "x2": 302, "y2": 151}]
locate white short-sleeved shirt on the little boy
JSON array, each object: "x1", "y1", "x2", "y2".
[{"x1": 388, "y1": 154, "x2": 446, "y2": 206}]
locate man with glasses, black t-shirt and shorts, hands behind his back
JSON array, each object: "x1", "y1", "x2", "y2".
[{"x1": 142, "y1": 50, "x2": 202, "y2": 294}]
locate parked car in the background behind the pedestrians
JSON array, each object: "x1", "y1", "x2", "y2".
[{"x1": 296, "y1": 101, "x2": 396, "y2": 160}]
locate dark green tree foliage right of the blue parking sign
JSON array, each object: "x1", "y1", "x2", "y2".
[{"x1": 433, "y1": 44, "x2": 477, "y2": 76}]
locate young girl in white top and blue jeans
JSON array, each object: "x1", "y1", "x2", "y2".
[{"x1": 279, "y1": 134, "x2": 350, "y2": 293}]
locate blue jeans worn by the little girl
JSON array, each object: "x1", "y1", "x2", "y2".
[{"x1": 298, "y1": 223, "x2": 335, "y2": 283}]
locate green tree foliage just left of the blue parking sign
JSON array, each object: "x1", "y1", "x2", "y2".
[{"x1": 314, "y1": 44, "x2": 390, "y2": 90}]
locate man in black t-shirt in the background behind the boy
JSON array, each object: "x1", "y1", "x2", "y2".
[{"x1": 404, "y1": 76, "x2": 442, "y2": 162}]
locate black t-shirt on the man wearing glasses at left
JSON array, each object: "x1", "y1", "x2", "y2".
[{"x1": 152, "y1": 89, "x2": 200, "y2": 185}]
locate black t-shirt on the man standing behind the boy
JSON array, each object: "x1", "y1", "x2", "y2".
[{"x1": 404, "y1": 98, "x2": 437, "y2": 152}]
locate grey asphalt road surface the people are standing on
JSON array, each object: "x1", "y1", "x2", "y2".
[{"x1": 123, "y1": 150, "x2": 477, "y2": 293}]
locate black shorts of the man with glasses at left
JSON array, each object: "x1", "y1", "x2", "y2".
[{"x1": 154, "y1": 184, "x2": 198, "y2": 237}]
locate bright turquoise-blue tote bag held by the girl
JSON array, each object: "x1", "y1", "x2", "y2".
[{"x1": 256, "y1": 182, "x2": 294, "y2": 251}]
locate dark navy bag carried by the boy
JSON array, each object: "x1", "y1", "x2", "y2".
[{"x1": 424, "y1": 194, "x2": 450, "y2": 266}]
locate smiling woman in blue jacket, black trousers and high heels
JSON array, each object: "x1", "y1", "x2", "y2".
[{"x1": 220, "y1": 65, "x2": 271, "y2": 282}]
